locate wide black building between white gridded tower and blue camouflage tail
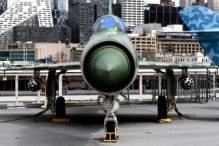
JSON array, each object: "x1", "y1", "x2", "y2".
[{"x1": 144, "y1": 4, "x2": 188, "y2": 27}]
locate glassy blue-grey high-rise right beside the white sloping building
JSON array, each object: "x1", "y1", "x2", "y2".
[{"x1": 51, "y1": 0, "x2": 68, "y2": 27}]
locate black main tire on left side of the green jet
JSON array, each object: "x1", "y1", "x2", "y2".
[{"x1": 56, "y1": 96, "x2": 66, "y2": 118}]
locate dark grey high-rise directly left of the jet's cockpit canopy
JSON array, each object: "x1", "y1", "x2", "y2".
[{"x1": 69, "y1": 2, "x2": 102, "y2": 43}]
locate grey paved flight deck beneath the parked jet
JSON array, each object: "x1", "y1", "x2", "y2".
[{"x1": 0, "y1": 101, "x2": 219, "y2": 146}]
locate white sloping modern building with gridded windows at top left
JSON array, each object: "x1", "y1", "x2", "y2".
[{"x1": 0, "y1": 0, "x2": 54, "y2": 43}]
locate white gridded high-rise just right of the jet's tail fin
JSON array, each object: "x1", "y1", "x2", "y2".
[{"x1": 121, "y1": 0, "x2": 144, "y2": 28}]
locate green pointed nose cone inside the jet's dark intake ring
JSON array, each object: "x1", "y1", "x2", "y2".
[{"x1": 90, "y1": 47, "x2": 129, "y2": 86}]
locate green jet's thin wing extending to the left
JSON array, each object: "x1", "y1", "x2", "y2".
[{"x1": 2, "y1": 62, "x2": 81, "y2": 70}]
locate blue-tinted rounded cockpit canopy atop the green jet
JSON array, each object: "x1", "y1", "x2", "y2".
[{"x1": 93, "y1": 15, "x2": 126, "y2": 33}]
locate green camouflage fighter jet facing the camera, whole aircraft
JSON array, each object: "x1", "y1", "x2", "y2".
[{"x1": 0, "y1": 0, "x2": 216, "y2": 139}]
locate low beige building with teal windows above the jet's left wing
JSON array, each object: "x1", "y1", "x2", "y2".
[{"x1": 0, "y1": 42, "x2": 79, "y2": 62}]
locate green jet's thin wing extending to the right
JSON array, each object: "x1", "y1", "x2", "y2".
[{"x1": 139, "y1": 61, "x2": 216, "y2": 69}]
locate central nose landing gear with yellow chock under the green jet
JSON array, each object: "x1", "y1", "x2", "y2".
[{"x1": 104, "y1": 96, "x2": 119, "y2": 142}]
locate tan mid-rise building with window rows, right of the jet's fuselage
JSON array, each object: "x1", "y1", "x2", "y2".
[{"x1": 129, "y1": 23, "x2": 204, "y2": 61}]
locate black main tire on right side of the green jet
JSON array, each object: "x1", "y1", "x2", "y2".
[{"x1": 157, "y1": 96, "x2": 167, "y2": 119}]
